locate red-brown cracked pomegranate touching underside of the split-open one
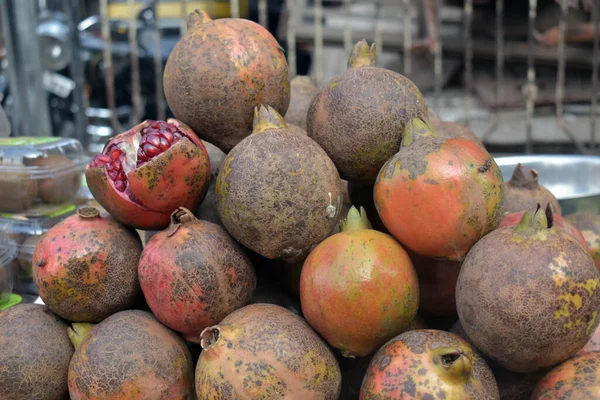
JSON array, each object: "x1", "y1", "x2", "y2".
[{"x1": 138, "y1": 207, "x2": 256, "y2": 343}]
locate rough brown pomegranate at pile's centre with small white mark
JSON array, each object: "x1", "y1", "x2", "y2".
[{"x1": 216, "y1": 106, "x2": 343, "y2": 262}]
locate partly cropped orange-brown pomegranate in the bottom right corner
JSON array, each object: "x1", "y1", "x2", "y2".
[{"x1": 531, "y1": 353, "x2": 600, "y2": 400}]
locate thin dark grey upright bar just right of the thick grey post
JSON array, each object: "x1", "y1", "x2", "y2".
[{"x1": 67, "y1": 0, "x2": 89, "y2": 148}]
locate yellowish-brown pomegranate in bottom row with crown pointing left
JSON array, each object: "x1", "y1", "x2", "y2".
[{"x1": 196, "y1": 304, "x2": 341, "y2": 400}]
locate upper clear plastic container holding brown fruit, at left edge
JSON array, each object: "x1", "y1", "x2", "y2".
[{"x1": 0, "y1": 137, "x2": 90, "y2": 213}]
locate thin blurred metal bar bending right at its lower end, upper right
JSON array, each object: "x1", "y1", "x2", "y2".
[{"x1": 555, "y1": 0, "x2": 586, "y2": 154}]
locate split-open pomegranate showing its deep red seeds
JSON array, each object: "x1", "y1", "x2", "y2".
[{"x1": 85, "y1": 119, "x2": 210, "y2": 230}]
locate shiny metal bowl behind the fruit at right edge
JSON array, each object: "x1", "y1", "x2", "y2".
[{"x1": 494, "y1": 155, "x2": 600, "y2": 215}]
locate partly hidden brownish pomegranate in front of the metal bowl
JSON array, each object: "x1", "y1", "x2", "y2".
[{"x1": 504, "y1": 164, "x2": 561, "y2": 214}]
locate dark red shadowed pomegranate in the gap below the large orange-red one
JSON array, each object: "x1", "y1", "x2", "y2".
[{"x1": 410, "y1": 254, "x2": 462, "y2": 317}]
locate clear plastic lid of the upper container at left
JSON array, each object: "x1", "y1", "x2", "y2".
[{"x1": 0, "y1": 136, "x2": 90, "y2": 179}]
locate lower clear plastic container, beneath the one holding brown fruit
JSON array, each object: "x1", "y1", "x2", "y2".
[{"x1": 0, "y1": 204, "x2": 77, "y2": 294}]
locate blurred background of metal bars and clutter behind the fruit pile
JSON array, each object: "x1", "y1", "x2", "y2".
[{"x1": 0, "y1": 0, "x2": 599, "y2": 154}]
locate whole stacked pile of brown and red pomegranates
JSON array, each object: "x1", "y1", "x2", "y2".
[{"x1": 0, "y1": 11, "x2": 600, "y2": 400}]
